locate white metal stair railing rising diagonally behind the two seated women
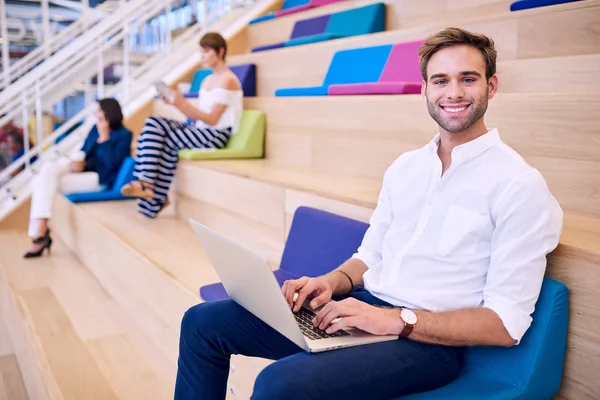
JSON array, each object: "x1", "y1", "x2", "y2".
[{"x1": 0, "y1": 0, "x2": 251, "y2": 217}]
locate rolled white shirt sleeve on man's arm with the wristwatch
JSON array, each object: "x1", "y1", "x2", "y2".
[{"x1": 483, "y1": 170, "x2": 563, "y2": 343}]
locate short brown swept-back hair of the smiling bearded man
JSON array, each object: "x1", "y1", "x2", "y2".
[{"x1": 419, "y1": 28, "x2": 497, "y2": 82}]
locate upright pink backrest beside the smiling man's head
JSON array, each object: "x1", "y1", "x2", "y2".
[{"x1": 379, "y1": 40, "x2": 423, "y2": 82}]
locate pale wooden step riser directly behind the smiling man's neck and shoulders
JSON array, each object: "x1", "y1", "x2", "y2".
[{"x1": 155, "y1": 94, "x2": 600, "y2": 219}]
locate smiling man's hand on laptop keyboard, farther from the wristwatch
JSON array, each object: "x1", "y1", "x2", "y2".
[{"x1": 281, "y1": 276, "x2": 333, "y2": 312}]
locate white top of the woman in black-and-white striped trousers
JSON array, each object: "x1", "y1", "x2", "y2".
[{"x1": 196, "y1": 88, "x2": 244, "y2": 133}]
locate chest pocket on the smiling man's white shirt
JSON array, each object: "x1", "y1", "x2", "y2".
[{"x1": 436, "y1": 206, "x2": 489, "y2": 257}]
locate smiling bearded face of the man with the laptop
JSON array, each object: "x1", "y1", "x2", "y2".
[{"x1": 424, "y1": 46, "x2": 498, "y2": 133}]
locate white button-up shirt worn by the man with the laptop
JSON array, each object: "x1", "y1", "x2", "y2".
[{"x1": 354, "y1": 129, "x2": 563, "y2": 341}]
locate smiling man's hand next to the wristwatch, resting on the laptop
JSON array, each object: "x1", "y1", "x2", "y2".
[{"x1": 313, "y1": 297, "x2": 404, "y2": 335}]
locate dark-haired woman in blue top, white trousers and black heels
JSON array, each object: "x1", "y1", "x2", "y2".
[{"x1": 24, "y1": 99, "x2": 132, "y2": 258}]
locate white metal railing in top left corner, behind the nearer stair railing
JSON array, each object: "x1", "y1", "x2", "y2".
[{"x1": 0, "y1": 0, "x2": 107, "y2": 89}]
